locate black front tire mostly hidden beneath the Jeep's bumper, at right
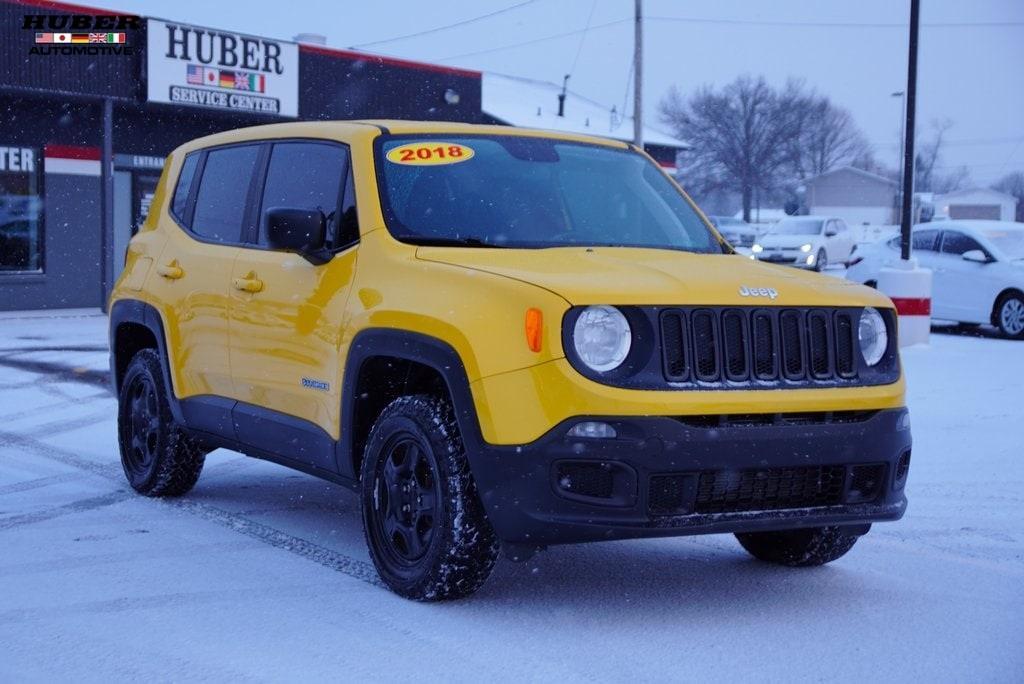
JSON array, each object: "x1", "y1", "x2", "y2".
[{"x1": 736, "y1": 527, "x2": 857, "y2": 567}]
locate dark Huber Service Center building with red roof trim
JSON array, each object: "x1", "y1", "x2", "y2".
[{"x1": 0, "y1": 0, "x2": 682, "y2": 310}]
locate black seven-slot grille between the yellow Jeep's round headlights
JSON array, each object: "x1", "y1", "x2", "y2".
[{"x1": 660, "y1": 307, "x2": 857, "y2": 384}]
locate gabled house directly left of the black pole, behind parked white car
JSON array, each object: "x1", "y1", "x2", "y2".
[{"x1": 803, "y1": 166, "x2": 899, "y2": 226}]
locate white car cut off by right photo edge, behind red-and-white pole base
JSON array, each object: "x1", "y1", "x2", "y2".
[{"x1": 846, "y1": 220, "x2": 1024, "y2": 339}]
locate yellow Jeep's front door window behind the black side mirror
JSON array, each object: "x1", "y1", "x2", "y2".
[{"x1": 259, "y1": 142, "x2": 348, "y2": 246}]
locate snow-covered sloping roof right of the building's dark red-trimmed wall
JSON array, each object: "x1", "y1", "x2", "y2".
[{"x1": 481, "y1": 72, "x2": 690, "y2": 149}]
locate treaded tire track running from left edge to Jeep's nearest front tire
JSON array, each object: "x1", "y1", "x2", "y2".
[{"x1": 0, "y1": 431, "x2": 384, "y2": 588}]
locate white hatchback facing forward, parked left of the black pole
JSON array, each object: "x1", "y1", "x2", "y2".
[{"x1": 751, "y1": 216, "x2": 857, "y2": 270}]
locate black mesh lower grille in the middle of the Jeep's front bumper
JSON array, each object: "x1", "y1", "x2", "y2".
[{"x1": 693, "y1": 466, "x2": 846, "y2": 513}]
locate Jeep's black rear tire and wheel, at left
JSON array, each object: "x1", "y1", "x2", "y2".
[{"x1": 118, "y1": 349, "x2": 206, "y2": 497}]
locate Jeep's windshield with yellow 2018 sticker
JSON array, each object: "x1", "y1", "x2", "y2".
[{"x1": 377, "y1": 135, "x2": 727, "y2": 253}]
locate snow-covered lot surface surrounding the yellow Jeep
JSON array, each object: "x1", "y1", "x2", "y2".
[{"x1": 0, "y1": 312, "x2": 1024, "y2": 682}]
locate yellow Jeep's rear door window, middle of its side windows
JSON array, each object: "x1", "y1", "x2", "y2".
[{"x1": 191, "y1": 144, "x2": 259, "y2": 243}]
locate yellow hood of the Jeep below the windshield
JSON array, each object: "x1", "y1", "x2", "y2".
[{"x1": 417, "y1": 247, "x2": 892, "y2": 307}]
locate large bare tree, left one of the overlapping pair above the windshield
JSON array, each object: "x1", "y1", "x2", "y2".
[{"x1": 659, "y1": 76, "x2": 803, "y2": 221}]
